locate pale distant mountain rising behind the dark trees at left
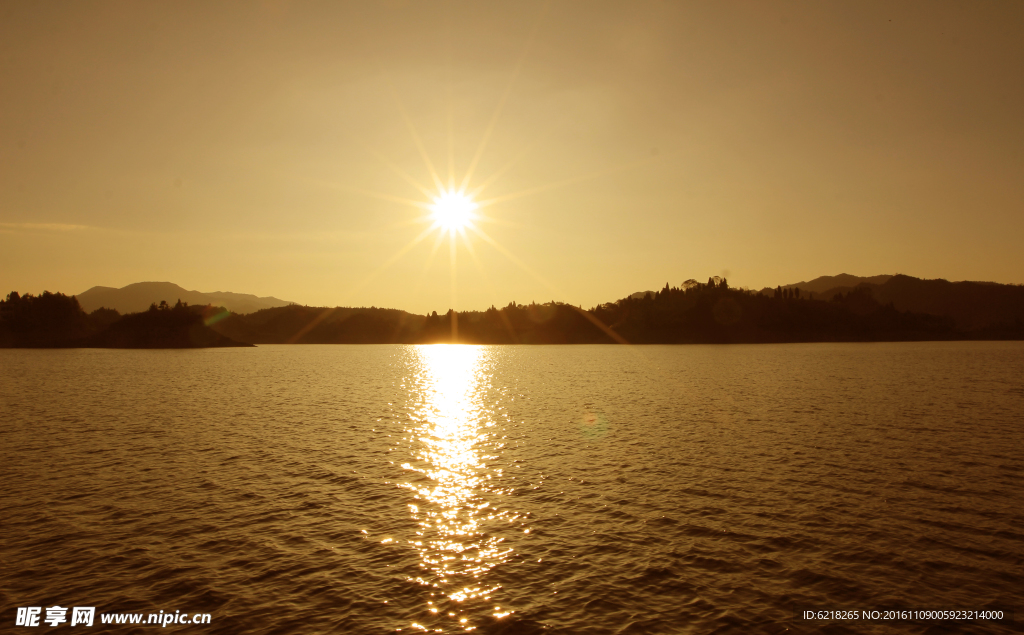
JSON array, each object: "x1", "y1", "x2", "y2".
[{"x1": 76, "y1": 283, "x2": 294, "y2": 314}]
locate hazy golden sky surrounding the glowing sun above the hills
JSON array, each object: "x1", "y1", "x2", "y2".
[{"x1": 0, "y1": 0, "x2": 1024, "y2": 312}]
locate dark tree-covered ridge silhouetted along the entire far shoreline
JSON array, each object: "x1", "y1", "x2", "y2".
[{"x1": 0, "y1": 276, "x2": 1024, "y2": 348}]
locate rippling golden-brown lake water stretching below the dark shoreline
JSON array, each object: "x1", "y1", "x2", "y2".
[{"x1": 0, "y1": 342, "x2": 1024, "y2": 633}]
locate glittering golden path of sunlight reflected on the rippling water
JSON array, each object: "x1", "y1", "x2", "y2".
[{"x1": 401, "y1": 344, "x2": 520, "y2": 630}]
